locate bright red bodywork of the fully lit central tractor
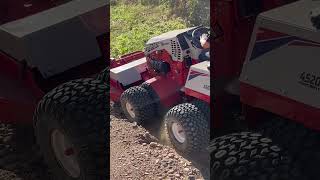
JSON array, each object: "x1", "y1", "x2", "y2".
[{"x1": 110, "y1": 42, "x2": 205, "y2": 108}]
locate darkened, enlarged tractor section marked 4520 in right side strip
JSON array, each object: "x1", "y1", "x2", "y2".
[{"x1": 209, "y1": 0, "x2": 320, "y2": 180}]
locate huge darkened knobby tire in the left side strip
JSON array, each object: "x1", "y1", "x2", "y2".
[{"x1": 34, "y1": 79, "x2": 109, "y2": 180}]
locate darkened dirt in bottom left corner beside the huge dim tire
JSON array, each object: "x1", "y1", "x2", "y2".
[{"x1": 0, "y1": 124, "x2": 50, "y2": 180}]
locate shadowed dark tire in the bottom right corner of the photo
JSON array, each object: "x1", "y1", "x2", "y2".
[{"x1": 260, "y1": 117, "x2": 320, "y2": 180}]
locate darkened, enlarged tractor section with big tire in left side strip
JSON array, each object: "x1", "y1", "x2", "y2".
[{"x1": 0, "y1": 0, "x2": 109, "y2": 180}]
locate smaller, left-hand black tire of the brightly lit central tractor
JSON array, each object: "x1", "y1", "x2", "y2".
[{"x1": 120, "y1": 86, "x2": 156, "y2": 124}]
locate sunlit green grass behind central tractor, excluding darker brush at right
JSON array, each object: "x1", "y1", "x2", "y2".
[{"x1": 110, "y1": 4, "x2": 187, "y2": 57}]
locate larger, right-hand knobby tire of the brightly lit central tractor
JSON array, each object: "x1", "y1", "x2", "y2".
[{"x1": 165, "y1": 103, "x2": 210, "y2": 155}]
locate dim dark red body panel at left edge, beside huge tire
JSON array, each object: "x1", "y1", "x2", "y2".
[{"x1": 0, "y1": 53, "x2": 44, "y2": 123}]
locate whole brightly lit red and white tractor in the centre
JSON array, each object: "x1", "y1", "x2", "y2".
[{"x1": 110, "y1": 26, "x2": 210, "y2": 154}]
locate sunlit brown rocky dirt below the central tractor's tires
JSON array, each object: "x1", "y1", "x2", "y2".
[{"x1": 110, "y1": 104, "x2": 208, "y2": 180}]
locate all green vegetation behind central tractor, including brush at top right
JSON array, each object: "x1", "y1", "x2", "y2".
[{"x1": 110, "y1": 0, "x2": 210, "y2": 57}]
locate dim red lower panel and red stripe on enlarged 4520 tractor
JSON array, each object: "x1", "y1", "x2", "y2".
[{"x1": 240, "y1": 28, "x2": 320, "y2": 130}]
